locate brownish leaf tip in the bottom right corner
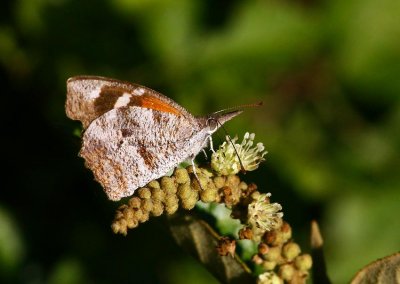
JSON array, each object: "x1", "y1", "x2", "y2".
[{"x1": 351, "y1": 252, "x2": 400, "y2": 284}]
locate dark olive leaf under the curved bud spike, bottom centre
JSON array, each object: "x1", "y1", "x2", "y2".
[{"x1": 169, "y1": 213, "x2": 255, "y2": 283}]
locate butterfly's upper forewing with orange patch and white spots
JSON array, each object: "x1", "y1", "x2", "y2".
[{"x1": 65, "y1": 76, "x2": 191, "y2": 128}]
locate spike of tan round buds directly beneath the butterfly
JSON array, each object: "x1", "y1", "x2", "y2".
[{"x1": 112, "y1": 166, "x2": 253, "y2": 235}]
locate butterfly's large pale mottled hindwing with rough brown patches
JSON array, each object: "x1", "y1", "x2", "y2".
[{"x1": 80, "y1": 107, "x2": 199, "y2": 200}]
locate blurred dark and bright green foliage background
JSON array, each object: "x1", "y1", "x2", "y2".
[{"x1": 0, "y1": 0, "x2": 400, "y2": 284}]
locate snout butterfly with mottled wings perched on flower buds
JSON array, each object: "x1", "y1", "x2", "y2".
[{"x1": 65, "y1": 76, "x2": 241, "y2": 201}]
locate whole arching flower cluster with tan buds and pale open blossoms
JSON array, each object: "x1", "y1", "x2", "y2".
[{"x1": 112, "y1": 133, "x2": 312, "y2": 284}]
